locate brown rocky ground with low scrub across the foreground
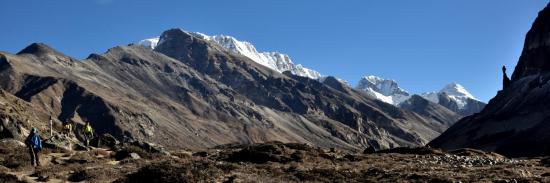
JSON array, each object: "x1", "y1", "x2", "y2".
[{"x1": 0, "y1": 139, "x2": 550, "y2": 183}]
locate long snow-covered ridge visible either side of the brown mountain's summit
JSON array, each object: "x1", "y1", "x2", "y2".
[{"x1": 138, "y1": 31, "x2": 322, "y2": 79}]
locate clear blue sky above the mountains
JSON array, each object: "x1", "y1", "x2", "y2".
[{"x1": 0, "y1": 0, "x2": 548, "y2": 101}]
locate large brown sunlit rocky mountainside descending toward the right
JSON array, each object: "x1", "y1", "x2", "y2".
[{"x1": 0, "y1": 29, "x2": 458, "y2": 152}]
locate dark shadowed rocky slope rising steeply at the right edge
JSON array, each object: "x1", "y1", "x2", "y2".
[{"x1": 430, "y1": 3, "x2": 550, "y2": 156}]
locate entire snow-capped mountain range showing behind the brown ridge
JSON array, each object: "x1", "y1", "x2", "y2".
[{"x1": 141, "y1": 31, "x2": 485, "y2": 116}]
